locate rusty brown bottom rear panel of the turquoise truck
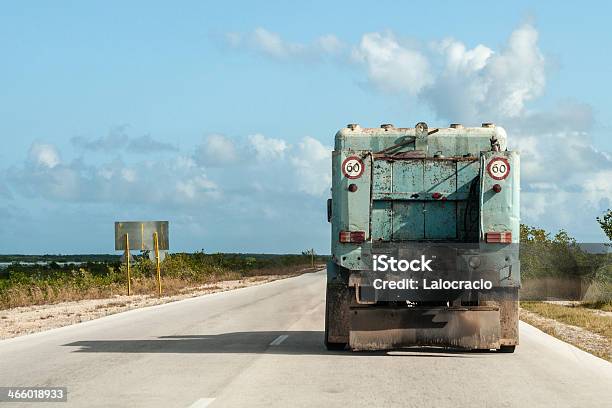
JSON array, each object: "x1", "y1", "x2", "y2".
[{"x1": 349, "y1": 306, "x2": 501, "y2": 350}]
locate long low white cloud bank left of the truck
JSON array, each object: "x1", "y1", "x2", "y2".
[{"x1": 9, "y1": 134, "x2": 331, "y2": 209}]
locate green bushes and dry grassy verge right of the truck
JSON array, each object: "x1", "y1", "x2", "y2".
[{"x1": 520, "y1": 214, "x2": 612, "y2": 361}]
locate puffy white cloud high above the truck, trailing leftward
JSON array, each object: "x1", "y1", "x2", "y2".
[{"x1": 226, "y1": 24, "x2": 546, "y2": 123}]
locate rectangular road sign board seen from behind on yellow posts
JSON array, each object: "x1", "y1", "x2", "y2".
[{"x1": 115, "y1": 221, "x2": 170, "y2": 251}]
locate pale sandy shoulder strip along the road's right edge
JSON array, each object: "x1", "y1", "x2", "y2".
[{"x1": 520, "y1": 309, "x2": 612, "y2": 361}]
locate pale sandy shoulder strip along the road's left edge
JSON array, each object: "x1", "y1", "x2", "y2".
[{"x1": 0, "y1": 274, "x2": 296, "y2": 339}]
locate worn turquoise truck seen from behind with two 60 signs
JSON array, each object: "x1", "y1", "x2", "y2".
[{"x1": 325, "y1": 122, "x2": 520, "y2": 352}]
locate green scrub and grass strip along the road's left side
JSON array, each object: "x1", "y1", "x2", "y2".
[{"x1": 0, "y1": 252, "x2": 326, "y2": 309}]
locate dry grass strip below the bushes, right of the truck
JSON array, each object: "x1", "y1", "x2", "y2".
[{"x1": 521, "y1": 302, "x2": 612, "y2": 341}]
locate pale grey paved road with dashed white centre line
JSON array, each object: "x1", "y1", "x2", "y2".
[{"x1": 0, "y1": 271, "x2": 612, "y2": 408}]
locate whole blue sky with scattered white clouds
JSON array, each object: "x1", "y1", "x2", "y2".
[{"x1": 0, "y1": 1, "x2": 612, "y2": 254}]
